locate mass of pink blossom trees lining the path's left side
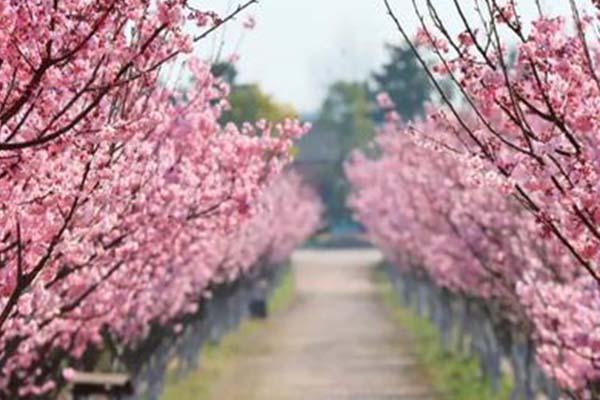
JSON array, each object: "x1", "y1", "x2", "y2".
[{"x1": 0, "y1": 0, "x2": 320, "y2": 398}]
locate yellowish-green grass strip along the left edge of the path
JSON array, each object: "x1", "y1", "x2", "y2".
[{"x1": 162, "y1": 269, "x2": 296, "y2": 400}]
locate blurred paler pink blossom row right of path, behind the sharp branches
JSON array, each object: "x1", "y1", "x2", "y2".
[{"x1": 346, "y1": 112, "x2": 600, "y2": 389}]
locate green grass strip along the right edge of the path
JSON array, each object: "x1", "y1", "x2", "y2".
[{"x1": 374, "y1": 268, "x2": 512, "y2": 400}]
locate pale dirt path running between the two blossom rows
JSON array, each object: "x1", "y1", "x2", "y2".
[{"x1": 209, "y1": 250, "x2": 433, "y2": 400}]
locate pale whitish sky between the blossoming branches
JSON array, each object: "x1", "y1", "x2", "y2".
[{"x1": 199, "y1": 0, "x2": 585, "y2": 112}]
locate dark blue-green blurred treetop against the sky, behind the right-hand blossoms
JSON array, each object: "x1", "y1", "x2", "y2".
[{"x1": 373, "y1": 44, "x2": 431, "y2": 120}]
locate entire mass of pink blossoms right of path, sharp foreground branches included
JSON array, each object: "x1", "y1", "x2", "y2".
[{"x1": 356, "y1": 1, "x2": 600, "y2": 398}]
